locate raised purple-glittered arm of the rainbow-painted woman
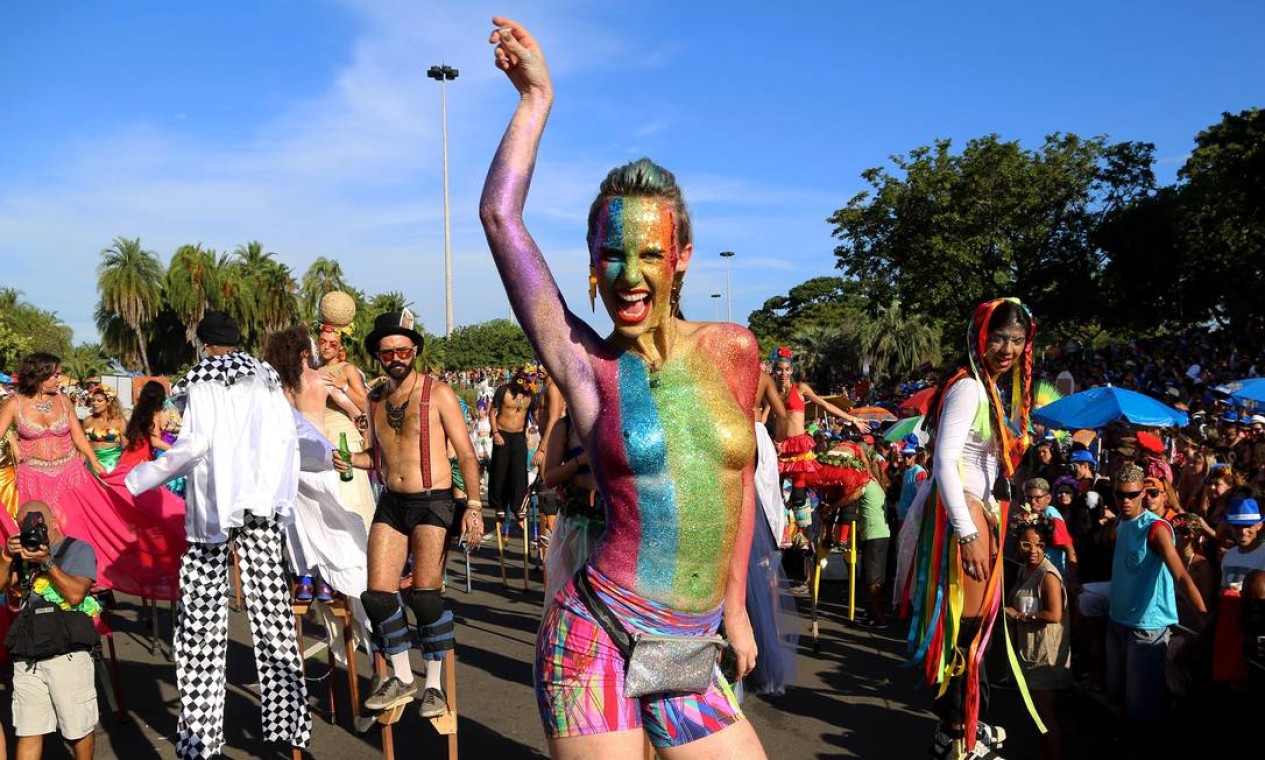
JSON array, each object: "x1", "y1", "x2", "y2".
[{"x1": 479, "y1": 16, "x2": 600, "y2": 430}]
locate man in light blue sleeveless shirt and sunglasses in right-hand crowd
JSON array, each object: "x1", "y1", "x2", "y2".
[{"x1": 1107, "y1": 465, "x2": 1207, "y2": 739}]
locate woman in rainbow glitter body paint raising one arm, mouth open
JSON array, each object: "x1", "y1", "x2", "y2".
[{"x1": 479, "y1": 16, "x2": 764, "y2": 759}]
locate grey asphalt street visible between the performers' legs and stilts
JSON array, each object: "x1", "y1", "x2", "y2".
[{"x1": 0, "y1": 533, "x2": 1111, "y2": 760}]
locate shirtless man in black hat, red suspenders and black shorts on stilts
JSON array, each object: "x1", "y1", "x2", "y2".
[{"x1": 334, "y1": 311, "x2": 480, "y2": 718}]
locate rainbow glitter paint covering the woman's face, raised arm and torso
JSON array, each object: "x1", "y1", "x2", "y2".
[{"x1": 479, "y1": 106, "x2": 759, "y2": 612}]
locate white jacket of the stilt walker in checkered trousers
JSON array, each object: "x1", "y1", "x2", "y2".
[{"x1": 127, "y1": 374, "x2": 300, "y2": 544}]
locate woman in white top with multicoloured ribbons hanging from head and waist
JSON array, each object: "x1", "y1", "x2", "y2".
[{"x1": 898, "y1": 298, "x2": 1036, "y2": 757}]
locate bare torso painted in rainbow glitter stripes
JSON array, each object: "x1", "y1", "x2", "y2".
[{"x1": 587, "y1": 350, "x2": 755, "y2": 612}]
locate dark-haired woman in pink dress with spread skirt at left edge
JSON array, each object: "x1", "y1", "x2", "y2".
[{"x1": 0, "y1": 353, "x2": 185, "y2": 599}]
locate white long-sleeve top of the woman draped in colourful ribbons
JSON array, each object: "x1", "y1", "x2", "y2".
[{"x1": 932, "y1": 377, "x2": 998, "y2": 536}]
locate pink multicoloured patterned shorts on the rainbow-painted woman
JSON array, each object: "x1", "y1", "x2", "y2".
[{"x1": 535, "y1": 568, "x2": 743, "y2": 747}]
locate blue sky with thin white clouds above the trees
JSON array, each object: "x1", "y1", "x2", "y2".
[{"x1": 0, "y1": 0, "x2": 1265, "y2": 341}]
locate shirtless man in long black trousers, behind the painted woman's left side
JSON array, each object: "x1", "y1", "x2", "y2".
[{"x1": 487, "y1": 369, "x2": 536, "y2": 520}]
